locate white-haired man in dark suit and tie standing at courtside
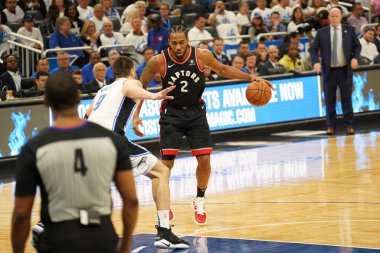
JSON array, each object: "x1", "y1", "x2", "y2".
[{"x1": 310, "y1": 8, "x2": 361, "y2": 135}]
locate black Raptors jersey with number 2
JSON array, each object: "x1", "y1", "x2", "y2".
[{"x1": 161, "y1": 47, "x2": 205, "y2": 106}]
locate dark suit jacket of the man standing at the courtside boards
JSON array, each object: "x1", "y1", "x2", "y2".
[{"x1": 309, "y1": 24, "x2": 362, "y2": 78}]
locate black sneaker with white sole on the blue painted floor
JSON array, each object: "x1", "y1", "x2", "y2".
[{"x1": 154, "y1": 225, "x2": 190, "y2": 249}]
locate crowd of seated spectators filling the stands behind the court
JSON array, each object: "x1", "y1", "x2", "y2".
[{"x1": 0, "y1": 0, "x2": 380, "y2": 98}]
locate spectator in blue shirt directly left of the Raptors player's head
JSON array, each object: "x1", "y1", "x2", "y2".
[{"x1": 148, "y1": 14, "x2": 169, "y2": 54}]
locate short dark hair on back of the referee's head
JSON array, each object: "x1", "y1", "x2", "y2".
[{"x1": 45, "y1": 73, "x2": 79, "y2": 111}]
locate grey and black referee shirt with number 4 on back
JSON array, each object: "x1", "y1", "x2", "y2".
[{"x1": 15, "y1": 122, "x2": 132, "y2": 225}]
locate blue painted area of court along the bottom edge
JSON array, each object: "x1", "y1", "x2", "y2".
[{"x1": 132, "y1": 234, "x2": 380, "y2": 253}]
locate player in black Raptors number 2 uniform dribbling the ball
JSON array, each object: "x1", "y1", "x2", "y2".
[{"x1": 133, "y1": 26, "x2": 270, "y2": 225}]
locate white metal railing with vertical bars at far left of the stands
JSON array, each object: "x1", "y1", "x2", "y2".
[{"x1": 7, "y1": 32, "x2": 44, "y2": 77}]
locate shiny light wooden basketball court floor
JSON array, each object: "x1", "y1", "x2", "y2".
[{"x1": 0, "y1": 132, "x2": 380, "y2": 253}]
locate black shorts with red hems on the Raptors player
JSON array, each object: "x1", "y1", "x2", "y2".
[{"x1": 159, "y1": 100, "x2": 212, "y2": 159}]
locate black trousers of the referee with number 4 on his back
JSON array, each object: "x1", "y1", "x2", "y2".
[{"x1": 37, "y1": 216, "x2": 118, "y2": 253}]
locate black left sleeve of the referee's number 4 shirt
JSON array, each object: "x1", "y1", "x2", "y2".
[{"x1": 15, "y1": 145, "x2": 38, "y2": 197}]
